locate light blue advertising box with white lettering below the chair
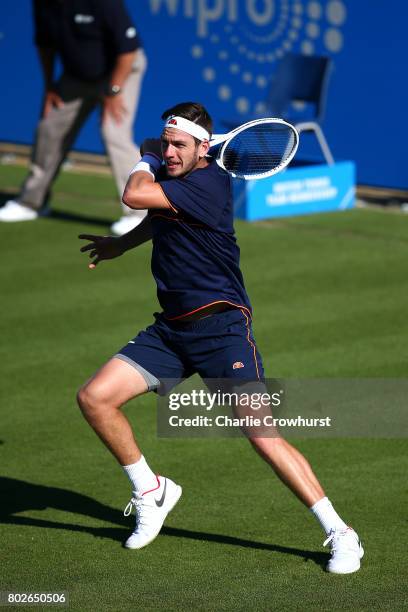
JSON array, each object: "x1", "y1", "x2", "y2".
[{"x1": 234, "y1": 162, "x2": 355, "y2": 221}]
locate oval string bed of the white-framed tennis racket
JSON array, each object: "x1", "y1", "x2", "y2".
[{"x1": 222, "y1": 124, "x2": 297, "y2": 178}]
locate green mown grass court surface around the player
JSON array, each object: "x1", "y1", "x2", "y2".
[{"x1": 0, "y1": 166, "x2": 408, "y2": 612}]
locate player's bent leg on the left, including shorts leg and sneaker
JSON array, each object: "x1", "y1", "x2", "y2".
[{"x1": 78, "y1": 323, "x2": 183, "y2": 548}]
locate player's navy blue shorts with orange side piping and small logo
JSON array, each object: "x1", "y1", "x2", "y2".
[{"x1": 116, "y1": 308, "x2": 264, "y2": 393}]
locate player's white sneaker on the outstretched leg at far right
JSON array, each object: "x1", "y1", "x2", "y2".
[{"x1": 323, "y1": 527, "x2": 364, "y2": 574}]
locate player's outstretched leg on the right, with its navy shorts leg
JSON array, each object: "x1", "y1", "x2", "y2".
[{"x1": 187, "y1": 311, "x2": 363, "y2": 574}]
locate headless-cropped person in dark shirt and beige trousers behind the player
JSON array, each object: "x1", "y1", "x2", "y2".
[{"x1": 0, "y1": 0, "x2": 147, "y2": 235}]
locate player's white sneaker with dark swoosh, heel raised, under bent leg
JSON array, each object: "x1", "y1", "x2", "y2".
[{"x1": 124, "y1": 476, "x2": 182, "y2": 548}]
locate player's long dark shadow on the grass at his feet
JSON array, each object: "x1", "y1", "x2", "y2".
[{"x1": 0, "y1": 477, "x2": 328, "y2": 567}]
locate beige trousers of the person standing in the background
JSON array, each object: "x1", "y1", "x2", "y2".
[{"x1": 18, "y1": 50, "x2": 147, "y2": 217}]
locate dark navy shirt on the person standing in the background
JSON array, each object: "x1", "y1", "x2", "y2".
[{"x1": 33, "y1": 0, "x2": 141, "y2": 81}]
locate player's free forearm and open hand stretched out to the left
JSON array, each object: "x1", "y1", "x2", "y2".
[{"x1": 78, "y1": 217, "x2": 152, "y2": 270}]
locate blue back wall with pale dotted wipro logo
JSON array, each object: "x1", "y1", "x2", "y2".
[{"x1": 0, "y1": 0, "x2": 408, "y2": 188}]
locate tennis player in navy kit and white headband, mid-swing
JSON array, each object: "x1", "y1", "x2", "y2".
[{"x1": 78, "y1": 102, "x2": 363, "y2": 574}]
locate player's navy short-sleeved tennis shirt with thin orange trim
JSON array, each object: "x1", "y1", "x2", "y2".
[{"x1": 149, "y1": 161, "x2": 251, "y2": 319}]
